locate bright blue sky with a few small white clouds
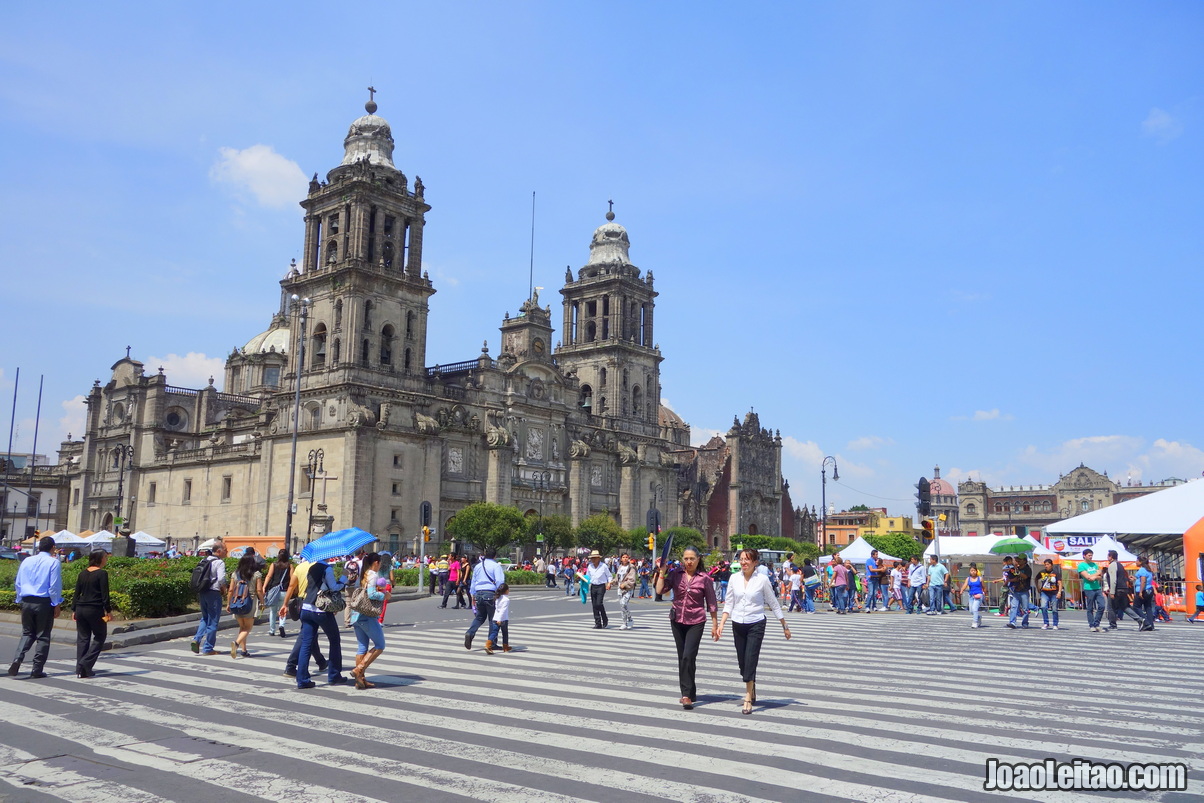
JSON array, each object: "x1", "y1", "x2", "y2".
[{"x1": 0, "y1": 2, "x2": 1204, "y2": 513}]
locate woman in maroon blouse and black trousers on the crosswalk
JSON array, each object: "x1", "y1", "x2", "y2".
[{"x1": 655, "y1": 547, "x2": 719, "y2": 710}]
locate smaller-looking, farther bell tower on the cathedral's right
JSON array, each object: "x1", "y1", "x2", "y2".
[{"x1": 556, "y1": 204, "x2": 663, "y2": 437}]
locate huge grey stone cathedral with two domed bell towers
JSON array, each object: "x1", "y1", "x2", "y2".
[{"x1": 59, "y1": 101, "x2": 795, "y2": 551}]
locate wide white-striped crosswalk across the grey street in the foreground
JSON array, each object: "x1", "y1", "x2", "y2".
[{"x1": 0, "y1": 606, "x2": 1204, "y2": 803}]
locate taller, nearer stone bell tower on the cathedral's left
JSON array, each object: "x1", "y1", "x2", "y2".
[{"x1": 281, "y1": 88, "x2": 435, "y2": 388}]
